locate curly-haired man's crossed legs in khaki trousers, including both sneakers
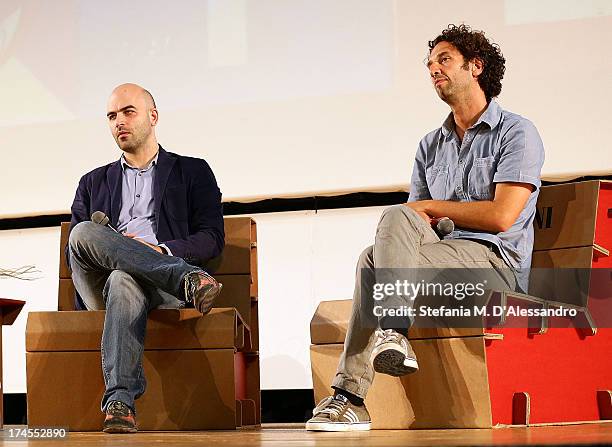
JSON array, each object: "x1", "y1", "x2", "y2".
[{"x1": 306, "y1": 205, "x2": 516, "y2": 431}]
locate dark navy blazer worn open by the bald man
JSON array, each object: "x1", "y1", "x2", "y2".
[{"x1": 70, "y1": 146, "x2": 225, "y2": 266}]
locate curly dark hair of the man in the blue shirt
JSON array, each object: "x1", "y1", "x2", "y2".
[{"x1": 428, "y1": 24, "x2": 506, "y2": 102}]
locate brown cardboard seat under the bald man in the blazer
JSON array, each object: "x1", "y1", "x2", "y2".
[{"x1": 26, "y1": 217, "x2": 261, "y2": 431}]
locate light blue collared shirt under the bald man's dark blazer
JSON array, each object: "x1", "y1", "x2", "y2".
[{"x1": 117, "y1": 155, "x2": 157, "y2": 245}]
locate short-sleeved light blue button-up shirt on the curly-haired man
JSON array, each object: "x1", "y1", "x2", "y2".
[{"x1": 408, "y1": 101, "x2": 544, "y2": 292}]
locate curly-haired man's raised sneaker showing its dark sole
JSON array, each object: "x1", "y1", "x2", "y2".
[{"x1": 370, "y1": 329, "x2": 419, "y2": 377}]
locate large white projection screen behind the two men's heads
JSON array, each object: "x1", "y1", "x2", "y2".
[{"x1": 0, "y1": 0, "x2": 612, "y2": 218}]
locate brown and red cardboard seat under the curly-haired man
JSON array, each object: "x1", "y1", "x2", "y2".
[{"x1": 310, "y1": 181, "x2": 612, "y2": 429}]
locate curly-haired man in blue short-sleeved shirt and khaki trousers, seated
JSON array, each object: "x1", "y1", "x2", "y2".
[{"x1": 306, "y1": 25, "x2": 544, "y2": 431}]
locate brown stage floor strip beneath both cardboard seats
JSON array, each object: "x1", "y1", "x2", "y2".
[{"x1": 0, "y1": 423, "x2": 612, "y2": 447}]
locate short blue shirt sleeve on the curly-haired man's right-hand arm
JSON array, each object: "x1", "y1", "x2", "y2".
[{"x1": 493, "y1": 119, "x2": 544, "y2": 189}]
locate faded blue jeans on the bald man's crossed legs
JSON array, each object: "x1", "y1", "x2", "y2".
[{"x1": 68, "y1": 221, "x2": 199, "y2": 411}]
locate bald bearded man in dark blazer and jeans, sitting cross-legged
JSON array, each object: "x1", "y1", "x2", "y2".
[{"x1": 67, "y1": 84, "x2": 224, "y2": 433}]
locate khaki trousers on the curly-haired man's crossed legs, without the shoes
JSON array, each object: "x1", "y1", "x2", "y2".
[{"x1": 332, "y1": 205, "x2": 516, "y2": 398}]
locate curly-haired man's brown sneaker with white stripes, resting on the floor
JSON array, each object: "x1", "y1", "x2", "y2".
[{"x1": 306, "y1": 394, "x2": 372, "y2": 431}]
